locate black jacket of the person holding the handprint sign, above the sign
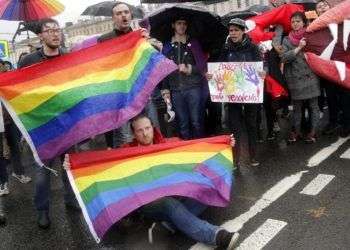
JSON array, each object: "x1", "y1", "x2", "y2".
[{"x1": 218, "y1": 35, "x2": 262, "y2": 62}]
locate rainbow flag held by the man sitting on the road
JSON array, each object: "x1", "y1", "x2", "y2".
[{"x1": 64, "y1": 136, "x2": 233, "y2": 242}]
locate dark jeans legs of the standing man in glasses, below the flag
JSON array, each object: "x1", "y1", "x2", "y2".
[{"x1": 34, "y1": 159, "x2": 76, "y2": 212}]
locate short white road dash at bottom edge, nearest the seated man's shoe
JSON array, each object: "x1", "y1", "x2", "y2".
[{"x1": 237, "y1": 219, "x2": 287, "y2": 250}]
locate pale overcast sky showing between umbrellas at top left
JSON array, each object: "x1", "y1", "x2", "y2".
[{"x1": 0, "y1": 0, "x2": 140, "y2": 40}]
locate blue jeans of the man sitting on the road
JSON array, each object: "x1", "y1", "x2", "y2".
[{"x1": 140, "y1": 197, "x2": 221, "y2": 246}]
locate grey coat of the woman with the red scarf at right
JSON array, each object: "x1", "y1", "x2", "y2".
[{"x1": 281, "y1": 37, "x2": 321, "y2": 100}]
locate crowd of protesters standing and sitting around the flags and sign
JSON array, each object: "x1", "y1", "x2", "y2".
[{"x1": 0, "y1": 0, "x2": 350, "y2": 249}]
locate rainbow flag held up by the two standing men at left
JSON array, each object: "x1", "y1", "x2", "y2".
[{"x1": 0, "y1": 31, "x2": 176, "y2": 163}]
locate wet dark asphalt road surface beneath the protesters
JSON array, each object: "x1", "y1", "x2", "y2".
[{"x1": 0, "y1": 117, "x2": 350, "y2": 250}]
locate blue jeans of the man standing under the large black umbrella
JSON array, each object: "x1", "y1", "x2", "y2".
[{"x1": 171, "y1": 87, "x2": 204, "y2": 140}]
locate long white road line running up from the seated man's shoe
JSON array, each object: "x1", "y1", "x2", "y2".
[{"x1": 190, "y1": 171, "x2": 308, "y2": 250}]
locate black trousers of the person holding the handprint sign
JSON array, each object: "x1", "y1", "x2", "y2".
[{"x1": 228, "y1": 103, "x2": 259, "y2": 166}]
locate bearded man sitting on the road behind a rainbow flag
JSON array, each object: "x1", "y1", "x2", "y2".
[{"x1": 124, "y1": 114, "x2": 239, "y2": 249}]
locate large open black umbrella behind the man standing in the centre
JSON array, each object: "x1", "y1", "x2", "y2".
[{"x1": 141, "y1": 4, "x2": 227, "y2": 52}]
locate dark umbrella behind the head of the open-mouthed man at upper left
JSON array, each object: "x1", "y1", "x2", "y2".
[{"x1": 81, "y1": 1, "x2": 144, "y2": 19}]
